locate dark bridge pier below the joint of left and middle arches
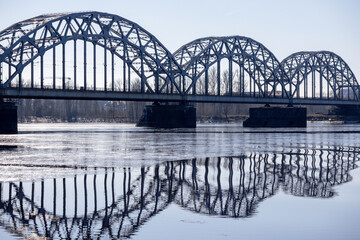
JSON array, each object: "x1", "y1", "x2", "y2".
[{"x1": 136, "y1": 103, "x2": 196, "y2": 128}]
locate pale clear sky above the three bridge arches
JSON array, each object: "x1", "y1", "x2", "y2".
[{"x1": 0, "y1": 0, "x2": 360, "y2": 77}]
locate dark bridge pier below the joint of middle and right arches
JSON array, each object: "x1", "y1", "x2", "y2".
[{"x1": 243, "y1": 107, "x2": 306, "y2": 127}]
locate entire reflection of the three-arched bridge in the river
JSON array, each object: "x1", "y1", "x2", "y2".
[{"x1": 0, "y1": 148, "x2": 360, "y2": 238}]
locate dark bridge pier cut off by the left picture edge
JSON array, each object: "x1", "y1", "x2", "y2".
[{"x1": 0, "y1": 99, "x2": 18, "y2": 134}]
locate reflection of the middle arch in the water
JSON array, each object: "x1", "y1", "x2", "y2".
[{"x1": 175, "y1": 155, "x2": 279, "y2": 217}]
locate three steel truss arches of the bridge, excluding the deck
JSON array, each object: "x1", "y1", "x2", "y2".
[{"x1": 0, "y1": 12, "x2": 360, "y2": 102}]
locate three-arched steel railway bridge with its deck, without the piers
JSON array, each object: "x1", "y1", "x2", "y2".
[{"x1": 0, "y1": 12, "x2": 360, "y2": 105}]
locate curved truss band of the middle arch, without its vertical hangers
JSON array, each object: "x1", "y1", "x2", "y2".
[{"x1": 174, "y1": 36, "x2": 282, "y2": 97}]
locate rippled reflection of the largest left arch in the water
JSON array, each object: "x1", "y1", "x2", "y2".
[{"x1": 0, "y1": 166, "x2": 174, "y2": 239}]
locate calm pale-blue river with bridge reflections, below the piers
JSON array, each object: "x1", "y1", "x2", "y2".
[{"x1": 0, "y1": 122, "x2": 360, "y2": 239}]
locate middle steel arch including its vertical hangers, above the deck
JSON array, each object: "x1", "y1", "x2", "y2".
[{"x1": 174, "y1": 36, "x2": 282, "y2": 97}]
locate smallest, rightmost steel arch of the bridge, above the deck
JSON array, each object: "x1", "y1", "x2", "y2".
[{"x1": 281, "y1": 51, "x2": 360, "y2": 100}]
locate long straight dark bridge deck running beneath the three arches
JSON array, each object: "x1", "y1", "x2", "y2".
[{"x1": 0, "y1": 88, "x2": 360, "y2": 105}]
